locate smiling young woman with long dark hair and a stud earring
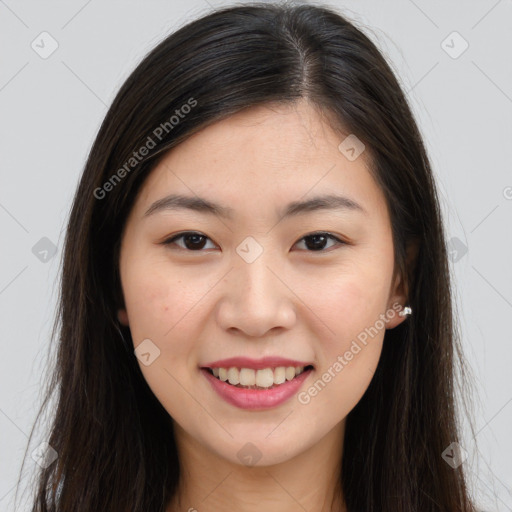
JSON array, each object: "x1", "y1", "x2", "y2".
[{"x1": 18, "y1": 3, "x2": 474, "y2": 512}]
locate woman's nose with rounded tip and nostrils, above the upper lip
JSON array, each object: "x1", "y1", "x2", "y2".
[{"x1": 217, "y1": 251, "x2": 296, "y2": 338}]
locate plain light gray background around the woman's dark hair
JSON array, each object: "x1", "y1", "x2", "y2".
[{"x1": 0, "y1": 0, "x2": 512, "y2": 511}]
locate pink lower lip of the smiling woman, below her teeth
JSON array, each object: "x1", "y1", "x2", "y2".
[{"x1": 201, "y1": 368, "x2": 312, "y2": 409}]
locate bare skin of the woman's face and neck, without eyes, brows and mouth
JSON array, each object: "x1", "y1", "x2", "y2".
[{"x1": 118, "y1": 101, "x2": 407, "y2": 512}]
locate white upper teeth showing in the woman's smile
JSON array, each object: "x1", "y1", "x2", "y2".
[{"x1": 212, "y1": 366, "x2": 304, "y2": 388}]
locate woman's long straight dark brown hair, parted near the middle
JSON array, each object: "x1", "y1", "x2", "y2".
[{"x1": 17, "y1": 3, "x2": 480, "y2": 512}]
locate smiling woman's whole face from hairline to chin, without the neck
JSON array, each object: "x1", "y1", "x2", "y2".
[{"x1": 119, "y1": 102, "x2": 405, "y2": 465}]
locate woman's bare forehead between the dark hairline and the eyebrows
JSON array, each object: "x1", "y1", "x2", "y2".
[{"x1": 131, "y1": 102, "x2": 386, "y2": 222}]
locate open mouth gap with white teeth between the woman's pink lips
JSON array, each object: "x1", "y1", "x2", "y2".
[{"x1": 201, "y1": 365, "x2": 313, "y2": 390}]
